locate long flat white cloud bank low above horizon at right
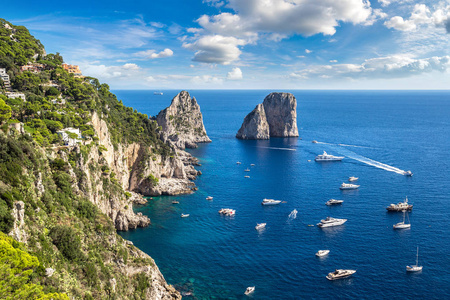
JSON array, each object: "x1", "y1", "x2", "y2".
[{"x1": 290, "y1": 55, "x2": 450, "y2": 79}]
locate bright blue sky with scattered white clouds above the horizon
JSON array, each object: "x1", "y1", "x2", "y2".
[{"x1": 0, "y1": 0, "x2": 450, "y2": 89}]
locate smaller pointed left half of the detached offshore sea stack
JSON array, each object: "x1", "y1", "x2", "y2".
[{"x1": 236, "y1": 104, "x2": 270, "y2": 140}]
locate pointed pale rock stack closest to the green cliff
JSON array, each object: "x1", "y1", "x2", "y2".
[{"x1": 156, "y1": 91, "x2": 211, "y2": 149}]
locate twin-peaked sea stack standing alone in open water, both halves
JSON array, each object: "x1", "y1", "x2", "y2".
[{"x1": 236, "y1": 93, "x2": 298, "y2": 140}]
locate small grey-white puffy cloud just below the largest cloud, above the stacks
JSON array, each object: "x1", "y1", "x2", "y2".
[{"x1": 183, "y1": 35, "x2": 246, "y2": 65}]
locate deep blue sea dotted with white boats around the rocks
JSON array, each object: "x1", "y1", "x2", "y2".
[{"x1": 114, "y1": 90, "x2": 450, "y2": 299}]
